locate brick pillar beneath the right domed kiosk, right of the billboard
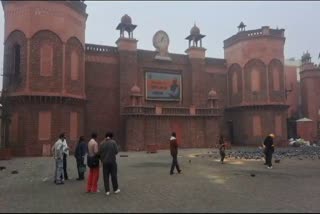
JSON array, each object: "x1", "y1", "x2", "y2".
[{"x1": 186, "y1": 47, "x2": 207, "y2": 106}]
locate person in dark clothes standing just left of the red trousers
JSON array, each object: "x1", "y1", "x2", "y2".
[{"x1": 74, "y1": 136, "x2": 87, "y2": 181}]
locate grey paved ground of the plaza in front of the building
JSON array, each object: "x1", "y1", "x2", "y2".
[{"x1": 0, "y1": 149, "x2": 320, "y2": 213}]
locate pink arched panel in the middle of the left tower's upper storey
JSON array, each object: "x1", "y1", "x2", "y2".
[{"x1": 40, "y1": 44, "x2": 53, "y2": 76}]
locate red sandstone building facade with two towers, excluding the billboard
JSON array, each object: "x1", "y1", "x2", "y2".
[{"x1": 2, "y1": 1, "x2": 302, "y2": 155}]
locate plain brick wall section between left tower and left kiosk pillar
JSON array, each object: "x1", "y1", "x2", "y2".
[{"x1": 85, "y1": 62, "x2": 120, "y2": 144}]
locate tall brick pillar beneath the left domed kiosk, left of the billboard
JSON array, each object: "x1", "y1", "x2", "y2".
[{"x1": 116, "y1": 38, "x2": 138, "y2": 150}]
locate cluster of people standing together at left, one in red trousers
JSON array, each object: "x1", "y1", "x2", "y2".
[{"x1": 52, "y1": 132, "x2": 120, "y2": 195}]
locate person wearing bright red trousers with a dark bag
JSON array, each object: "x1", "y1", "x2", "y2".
[{"x1": 87, "y1": 133, "x2": 100, "y2": 193}]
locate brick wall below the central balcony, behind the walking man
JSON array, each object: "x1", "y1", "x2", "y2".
[{"x1": 126, "y1": 117, "x2": 220, "y2": 150}]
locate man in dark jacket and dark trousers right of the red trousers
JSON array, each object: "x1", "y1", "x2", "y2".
[{"x1": 99, "y1": 132, "x2": 120, "y2": 195}]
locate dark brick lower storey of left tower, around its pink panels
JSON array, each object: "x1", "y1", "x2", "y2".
[{"x1": 10, "y1": 103, "x2": 84, "y2": 156}]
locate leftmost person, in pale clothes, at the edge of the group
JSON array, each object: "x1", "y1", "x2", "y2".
[{"x1": 51, "y1": 133, "x2": 64, "y2": 184}]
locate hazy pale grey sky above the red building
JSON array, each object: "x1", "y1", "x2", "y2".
[{"x1": 0, "y1": 1, "x2": 320, "y2": 88}]
